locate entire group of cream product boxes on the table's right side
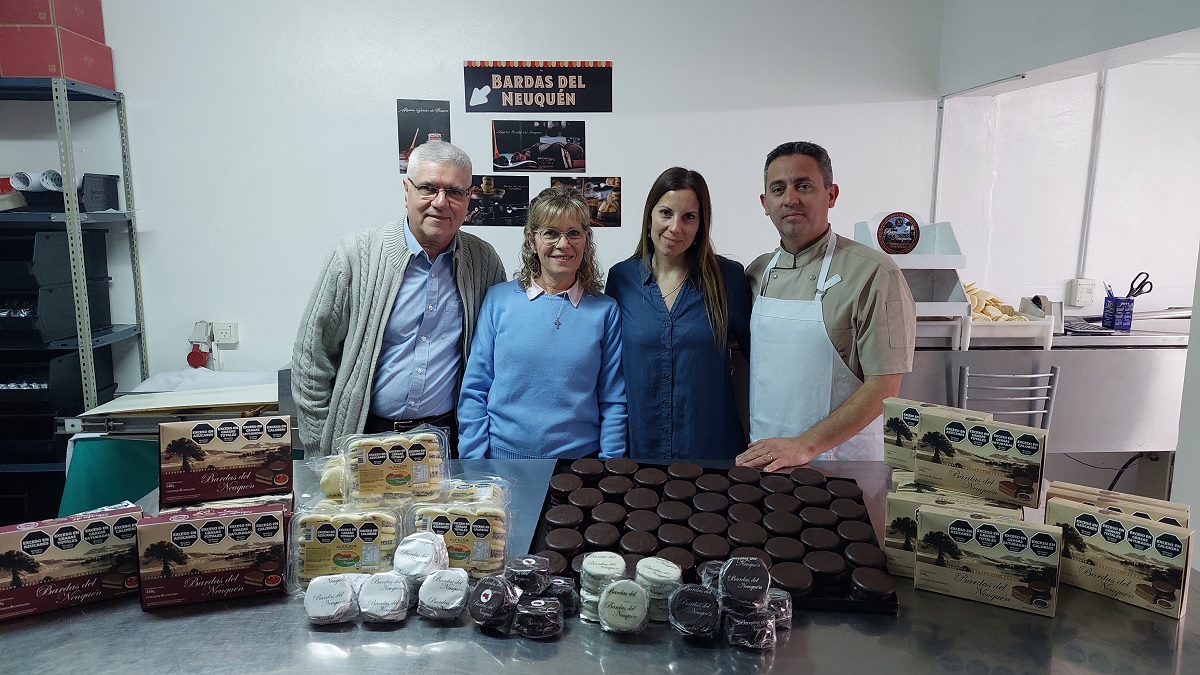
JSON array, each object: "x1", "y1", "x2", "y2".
[{"x1": 883, "y1": 399, "x2": 1193, "y2": 617}]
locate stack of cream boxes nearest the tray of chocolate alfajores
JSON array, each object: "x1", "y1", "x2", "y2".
[{"x1": 883, "y1": 399, "x2": 1062, "y2": 616}]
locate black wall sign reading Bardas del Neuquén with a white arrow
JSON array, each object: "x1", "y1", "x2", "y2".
[{"x1": 462, "y1": 61, "x2": 612, "y2": 113}]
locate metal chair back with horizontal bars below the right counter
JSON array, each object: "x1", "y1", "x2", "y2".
[{"x1": 959, "y1": 365, "x2": 1058, "y2": 429}]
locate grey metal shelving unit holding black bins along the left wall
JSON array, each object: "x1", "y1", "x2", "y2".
[{"x1": 0, "y1": 77, "x2": 149, "y2": 524}]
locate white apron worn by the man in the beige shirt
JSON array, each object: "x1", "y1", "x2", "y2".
[{"x1": 750, "y1": 232, "x2": 883, "y2": 460}]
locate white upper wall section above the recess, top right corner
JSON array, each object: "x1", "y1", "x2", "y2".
[{"x1": 938, "y1": 0, "x2": 1200, "y2": 95}]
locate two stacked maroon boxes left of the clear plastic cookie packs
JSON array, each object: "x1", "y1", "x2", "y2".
[{"x1": 137, "y1": 416, "x2": 293, "y2": 609}]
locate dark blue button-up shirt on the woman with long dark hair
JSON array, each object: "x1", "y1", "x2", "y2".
[{"x1": 605, "y1": 256, "x2": 750, "y2": 461}]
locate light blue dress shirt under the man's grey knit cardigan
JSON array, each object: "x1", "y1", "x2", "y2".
[{"x1": 371, "y1": 216, "x2": 462, "y2": 419}]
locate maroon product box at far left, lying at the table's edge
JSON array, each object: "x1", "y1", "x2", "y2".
[{"x1": 0, "y1": 507, "x2": 142, "y2": 620}]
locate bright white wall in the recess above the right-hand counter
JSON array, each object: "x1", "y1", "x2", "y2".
[{"x1": 938, "y1": 59, "x2": 1200, "y2": 309}]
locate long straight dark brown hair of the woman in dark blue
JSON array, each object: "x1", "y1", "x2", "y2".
[{"x1": 634, "y1": 167, "x2": 728, "y2": 350}]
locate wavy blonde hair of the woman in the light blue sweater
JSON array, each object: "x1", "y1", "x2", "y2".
[{"x1": 512, "y1": 185, "x2": 604, "y2": 293}]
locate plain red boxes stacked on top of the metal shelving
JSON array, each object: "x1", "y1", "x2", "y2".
[{"x1": 0, "y1": 0, "x2": 116, "y2": 89}]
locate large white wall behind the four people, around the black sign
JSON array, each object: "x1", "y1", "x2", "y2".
[{"x1": 91, "y1": 0, "x2": 942, "y2": 372}]
